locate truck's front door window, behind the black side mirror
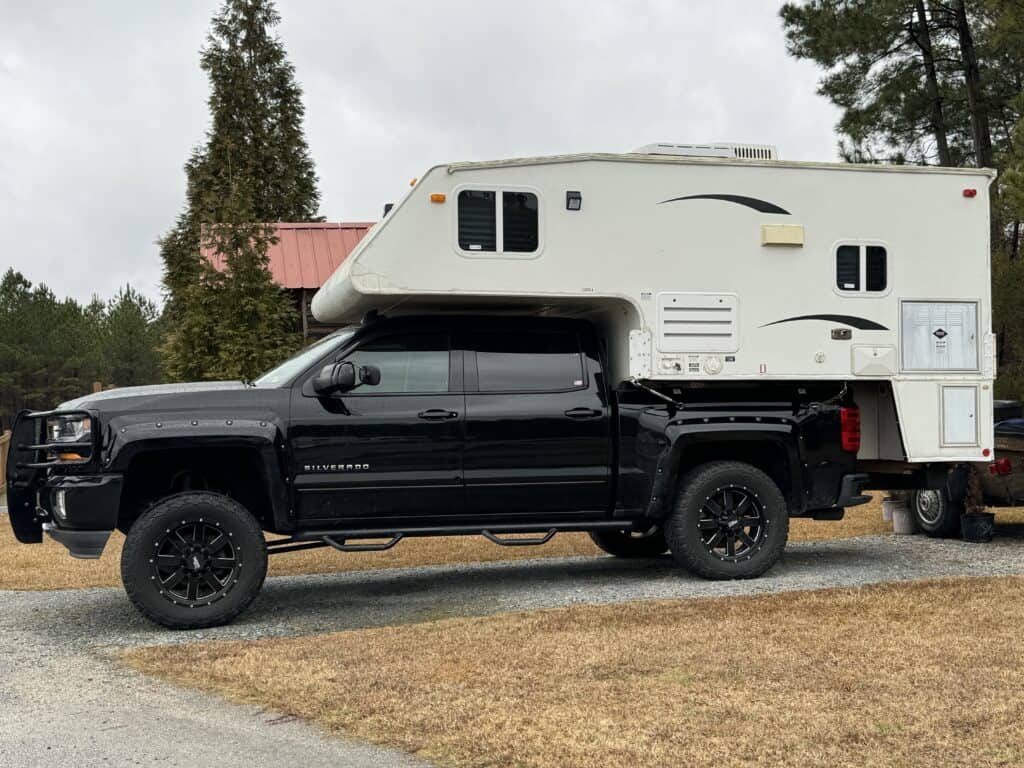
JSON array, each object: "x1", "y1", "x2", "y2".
[{"x1": 345, "y1": 332, "x2": 450, "y2": 394}]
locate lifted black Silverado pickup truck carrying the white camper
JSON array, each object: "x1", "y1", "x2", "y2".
[{"x1": 7, "y1": 316, "x2": 867, "y2": 628}]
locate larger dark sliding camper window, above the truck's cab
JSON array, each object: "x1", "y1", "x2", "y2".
[{"x1": 459, "y1": 189, "x2": 540, "y2": 254}]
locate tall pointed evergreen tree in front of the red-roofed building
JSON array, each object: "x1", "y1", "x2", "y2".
[{"x1": 161, "y1": 0, "x2": 319, "y2": 379}]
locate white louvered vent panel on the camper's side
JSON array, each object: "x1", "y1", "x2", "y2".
[{"x1": 657, "y1": 293, "x2": 739, "y2": 352}]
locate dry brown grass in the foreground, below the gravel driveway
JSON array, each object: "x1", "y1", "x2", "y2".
[{"x1": 126, "y1": 578, "x2": 1024, "y2": 768}]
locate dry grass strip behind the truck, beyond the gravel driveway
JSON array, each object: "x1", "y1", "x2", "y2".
[{"x1": 0, "y1": 502, "x2": 892, "y2": 590}]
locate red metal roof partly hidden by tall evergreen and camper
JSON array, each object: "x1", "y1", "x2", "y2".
[{"x1": 202, "y1": 227, "x2": 373, "y2": 288}]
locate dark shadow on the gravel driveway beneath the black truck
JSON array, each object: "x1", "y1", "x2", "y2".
[{"x1": 36, "y1": 544, "x2": 892, "y2": 647}]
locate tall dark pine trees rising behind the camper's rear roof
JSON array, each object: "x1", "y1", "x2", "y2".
[{"x1": 780, "y1": 0, "x2": 1024, "y2": 167}]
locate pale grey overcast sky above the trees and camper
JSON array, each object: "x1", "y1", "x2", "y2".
[{"x1": 0, "y1": 0, "x2": 838, "y2": 307}]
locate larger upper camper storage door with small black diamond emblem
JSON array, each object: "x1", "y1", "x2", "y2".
[{"x1": 900, "y1": 301, "x2": 979, "y2": 371}]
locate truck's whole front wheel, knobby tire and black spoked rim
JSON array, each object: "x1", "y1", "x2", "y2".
[{"x1": 121, "y1": 492, "x2": 266, "y2": 630}]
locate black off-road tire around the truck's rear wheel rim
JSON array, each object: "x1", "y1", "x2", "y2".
[{"x1": 665, "y1": 461, "x2": 790, "y2": 580}]
